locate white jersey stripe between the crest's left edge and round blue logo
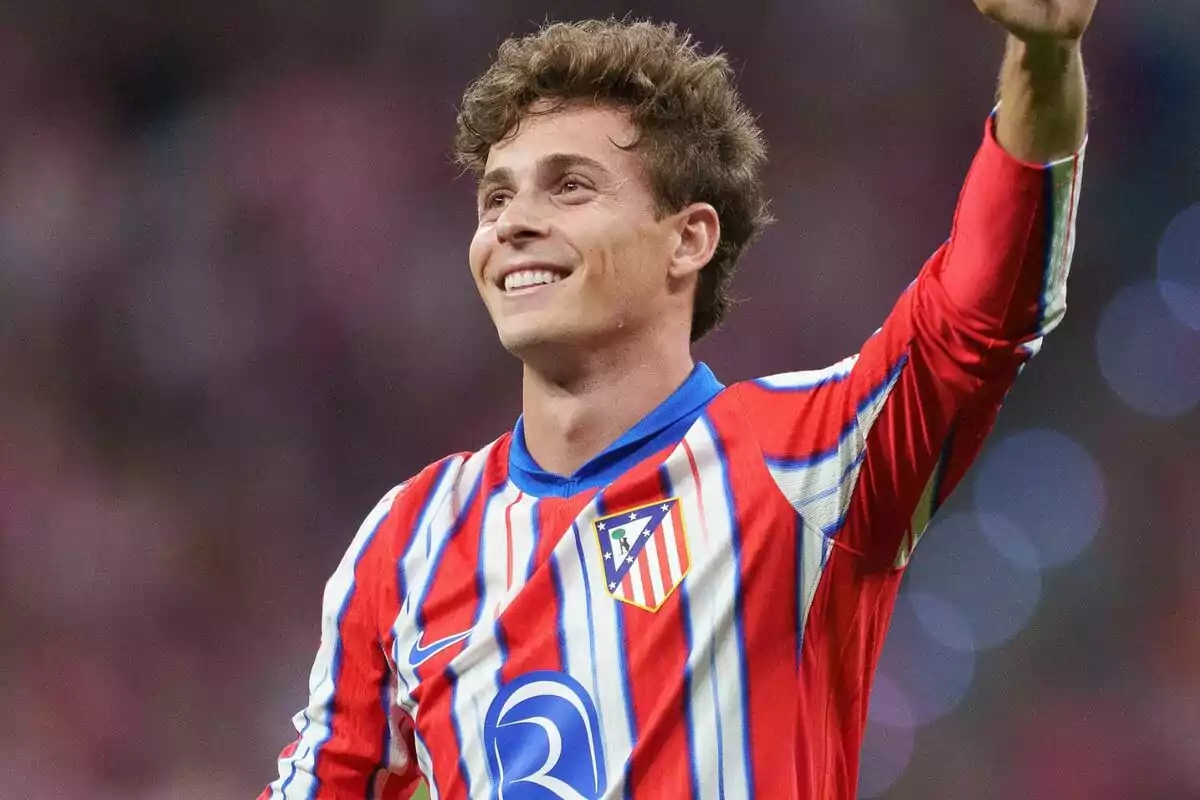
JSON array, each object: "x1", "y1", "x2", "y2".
[{"x1": 552, "y1": 510, "x2": 634, "y2": 798}]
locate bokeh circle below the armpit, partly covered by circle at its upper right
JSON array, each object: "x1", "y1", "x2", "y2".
[{"x1": 871, "y1": 587, "x2": 976, "y2": 724}]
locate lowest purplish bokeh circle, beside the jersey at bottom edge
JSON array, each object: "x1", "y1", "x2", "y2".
[{"x1": 858, "y1": 670, "x2": 916, "y2": 798}]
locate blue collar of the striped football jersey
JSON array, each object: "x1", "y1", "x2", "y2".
[{"x1": 509, "y1": 363, "x2": 725, "y2": 498}]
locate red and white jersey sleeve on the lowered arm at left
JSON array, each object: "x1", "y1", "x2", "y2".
[{"x1": 259, "y1": 487, "x2": 421, "y2": 800}]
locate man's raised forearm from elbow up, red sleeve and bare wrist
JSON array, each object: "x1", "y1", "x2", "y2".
[{"x1": 938, "y1": 0, "x2": 1096, "y2": 351}]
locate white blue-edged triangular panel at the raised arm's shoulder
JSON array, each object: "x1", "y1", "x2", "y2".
[{"x1": 768, "y1": 367, "x2": 902, "y2": 535}]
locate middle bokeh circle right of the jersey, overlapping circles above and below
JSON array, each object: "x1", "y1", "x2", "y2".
[{"x1": 908, "y1": 513, "x2": 1042, "y2": 648}]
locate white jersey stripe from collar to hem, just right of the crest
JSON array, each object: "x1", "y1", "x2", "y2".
[{"x1": 666, "y1": 420, "x2": 750, "y2": 800}]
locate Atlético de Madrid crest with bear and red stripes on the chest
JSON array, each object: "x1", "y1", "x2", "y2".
[{"x1": 593, "y1": 498, "x2": 691, "y2": 612}]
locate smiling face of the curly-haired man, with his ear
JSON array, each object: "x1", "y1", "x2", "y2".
[{"x1": 470, "y1": 106, "x2": 700, "y2": 361}]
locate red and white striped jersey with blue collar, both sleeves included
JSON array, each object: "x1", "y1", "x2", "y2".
[{"x1": 262, "y1": 115, "x2": 1082, "y2": 800}]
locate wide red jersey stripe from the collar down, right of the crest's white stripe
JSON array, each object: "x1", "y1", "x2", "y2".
[{"x1": 708, "y1": 396, "x2": 806, "y2": 796}]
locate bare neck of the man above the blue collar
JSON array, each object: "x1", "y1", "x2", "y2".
[{"x1": 522, "y1": 338, "x2": 694, "y2": 475}]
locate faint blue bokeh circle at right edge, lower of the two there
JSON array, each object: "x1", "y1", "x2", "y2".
[{"x1": 1096, "y1": 281, "x2": 1200, "y2": 419}]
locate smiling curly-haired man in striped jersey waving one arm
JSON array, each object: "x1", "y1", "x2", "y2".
[{"x1": 263, "y1": 0, "x2": 1094, "y2": 800}]
